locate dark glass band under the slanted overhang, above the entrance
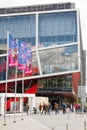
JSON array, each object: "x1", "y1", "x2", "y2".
[{"x1": 37, "y1": 75, "x2": 72, "y2": 94}]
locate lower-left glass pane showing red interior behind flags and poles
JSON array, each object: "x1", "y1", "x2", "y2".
[{"x1": 0, "y1": 51, "x2": 39, "y2": 81}]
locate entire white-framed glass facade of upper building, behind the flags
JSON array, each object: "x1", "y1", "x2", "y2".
[{"x1": 0, "y1": 11, "x2": 78, "y2": 81}]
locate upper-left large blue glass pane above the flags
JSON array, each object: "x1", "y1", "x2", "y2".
[{"x1": 0, "y1": 15, "x2": 36, "y2": 54}]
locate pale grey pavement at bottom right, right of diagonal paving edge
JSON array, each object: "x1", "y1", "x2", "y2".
[{"x1": 31, "y1": 112, "x2": 87, "y2": 130}]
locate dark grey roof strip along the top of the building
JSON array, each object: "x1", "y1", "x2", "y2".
[{"x1": 0, "y1": 2, "x2": 75, "y2": 14}]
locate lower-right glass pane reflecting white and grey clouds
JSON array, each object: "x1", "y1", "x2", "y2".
[{"x1": 39, "y1": 45, "x2": 78, "y2": 74}]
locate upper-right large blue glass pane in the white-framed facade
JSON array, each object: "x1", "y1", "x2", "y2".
[{"x1": 39, "y1": 11, "x2": 77, "y2": 47}]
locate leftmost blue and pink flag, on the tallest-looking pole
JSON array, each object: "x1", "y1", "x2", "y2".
[{"x1": 8, "y1": 34, "x2": 18, "y2": 67}]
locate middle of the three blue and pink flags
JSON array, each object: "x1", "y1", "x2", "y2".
[{"x1": 18, "y1": 40, "x2": 26, "y2": 70}]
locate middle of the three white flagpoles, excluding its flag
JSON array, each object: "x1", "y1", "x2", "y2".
[{"x1": 13, "y1": 39, "x2": 18, "y2": 123}]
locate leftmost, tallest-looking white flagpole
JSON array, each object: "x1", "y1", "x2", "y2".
[{"x1": 3, "y1": 31, "x2": 9, "y2": 126}]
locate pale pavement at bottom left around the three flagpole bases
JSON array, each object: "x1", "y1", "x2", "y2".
[{"x1": 0, "y1": 114, "x2": 49, "y2": 130}]
